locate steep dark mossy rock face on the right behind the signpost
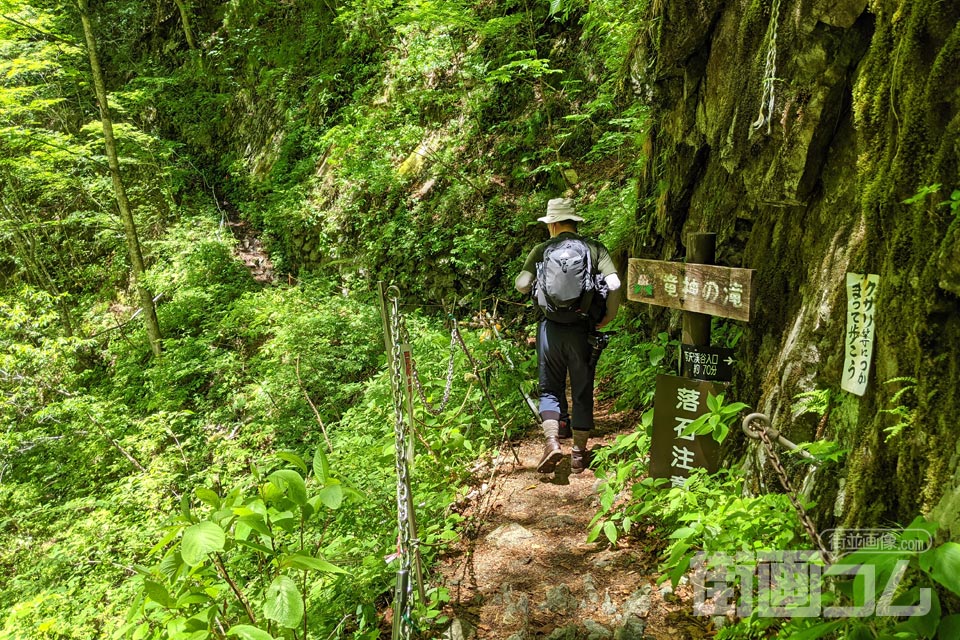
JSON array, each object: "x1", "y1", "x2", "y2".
[{"x1": 633, "y1": 0, "x2": 960, "y2": 537}]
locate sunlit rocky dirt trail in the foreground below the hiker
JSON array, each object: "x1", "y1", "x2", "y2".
[{"x1": 438, "y1": 406, "x2": 711, "y2": 640}]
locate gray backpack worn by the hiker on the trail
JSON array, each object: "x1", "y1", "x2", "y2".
[{"x1": 534, "y1": 238, "x2": 599, "y2": 323}]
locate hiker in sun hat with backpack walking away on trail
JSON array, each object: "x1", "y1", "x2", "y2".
[{"x1": 514, "y1": 198, "x2": 621, "y2": 473}]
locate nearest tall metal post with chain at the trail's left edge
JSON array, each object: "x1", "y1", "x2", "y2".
[{"x1": 378, "y1": 282, "x2": 425, "y2": 640}]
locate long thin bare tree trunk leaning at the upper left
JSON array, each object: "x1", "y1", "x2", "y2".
[{"x1": 77, "y1": 0, "x2": 161, "y2": 356}]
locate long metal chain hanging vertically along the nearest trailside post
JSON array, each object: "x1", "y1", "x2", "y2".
[{"x1": 390, "y1": 287, "x2": 412, "y2": 640}]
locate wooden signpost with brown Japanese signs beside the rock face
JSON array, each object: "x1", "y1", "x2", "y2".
[{"x1": 627, "y1": 233, "x2": 753, "y2": 478}]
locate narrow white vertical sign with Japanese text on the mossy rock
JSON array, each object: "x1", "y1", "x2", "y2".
[{"x1": 840, "y1": 273, "x2": 880, "y2": 396}]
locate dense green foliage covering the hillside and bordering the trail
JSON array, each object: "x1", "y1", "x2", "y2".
[{"x1": 0, "y1": 0, "x2": 958, "y2": 640}]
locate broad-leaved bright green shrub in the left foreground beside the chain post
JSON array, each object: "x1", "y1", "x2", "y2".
[{"x1": 121, "y1": 449, "x2": 352, "y2": 640}]
